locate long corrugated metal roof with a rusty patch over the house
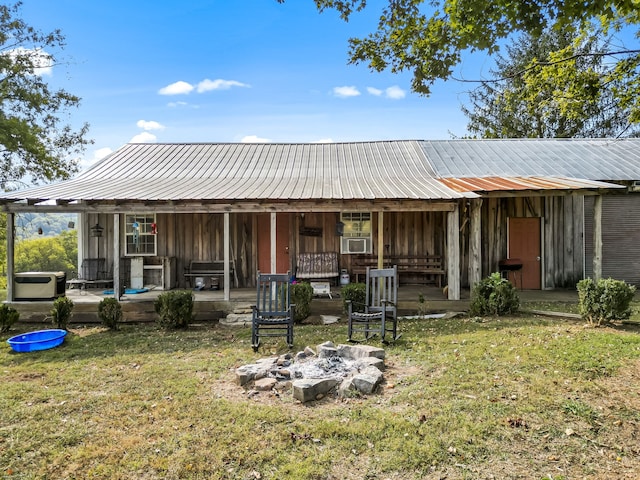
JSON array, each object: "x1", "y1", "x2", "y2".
[{"x1": 0, "y1": 139, "x2": 640, "y2": 203}]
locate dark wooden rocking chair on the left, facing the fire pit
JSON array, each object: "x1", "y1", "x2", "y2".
[{"x1": 251, "y1": 272, "x2": 295, "y2": 351}]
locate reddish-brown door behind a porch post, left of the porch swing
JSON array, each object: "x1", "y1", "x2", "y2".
[{"x1": 258, "y1": 213, "x2": 291, "y2": 273}]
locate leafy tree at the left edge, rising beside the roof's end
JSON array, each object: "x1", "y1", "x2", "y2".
[{"x1": 0, "y1": 3, "x2": 90, "y2": 188}]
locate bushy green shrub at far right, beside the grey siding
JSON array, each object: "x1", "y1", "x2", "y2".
[{"x1": 578, "y1": 278, "x2": 636, "y2": 325}]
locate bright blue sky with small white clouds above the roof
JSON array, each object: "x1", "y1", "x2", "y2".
[{"x1": 21, "y1": 0, "x2": 480, "y2": 170}]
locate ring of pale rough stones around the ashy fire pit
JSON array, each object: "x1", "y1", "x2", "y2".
[{"x1": 236, "y1": 342, "x2": 384, "y2": 403}]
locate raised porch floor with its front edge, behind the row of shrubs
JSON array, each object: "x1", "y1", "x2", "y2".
[{"x1": 12, "y1": 285, "x2": 578, "y2": 323}]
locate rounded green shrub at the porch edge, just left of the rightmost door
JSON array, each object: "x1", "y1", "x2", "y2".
[{"x1": 469, "y1": 272, "x2": 520, "y2": 316}]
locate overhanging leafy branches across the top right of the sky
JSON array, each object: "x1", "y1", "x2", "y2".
[{"x1": 288, "y1": 0, "x2": 640, "y2": 123}]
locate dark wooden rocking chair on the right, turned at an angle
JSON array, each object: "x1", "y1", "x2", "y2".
[{"x1": 347, "y1": 265, "x2": 400, "y2": 343}]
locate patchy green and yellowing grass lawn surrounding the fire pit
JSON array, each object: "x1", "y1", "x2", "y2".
[{"x1": 0, "y1": 314, "x2": 640, "y2": 480}]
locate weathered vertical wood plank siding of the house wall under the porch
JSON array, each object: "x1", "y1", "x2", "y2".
[{"x1": 85, "y1": 196, "x2": 592, "y2": 288}]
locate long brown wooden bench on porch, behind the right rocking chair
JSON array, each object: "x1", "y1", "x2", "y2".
[{"x1": 351, "y1": 255, "x2": 447, "y2": 287}]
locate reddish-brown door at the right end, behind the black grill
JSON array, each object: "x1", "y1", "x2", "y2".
[{"x1": 507, "y1": 217, "x2": 542, "y2": 290}]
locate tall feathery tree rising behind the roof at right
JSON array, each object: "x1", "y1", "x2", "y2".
[{"x1": 462, "y1": 25, "x2": 634, "y2": 138}]
